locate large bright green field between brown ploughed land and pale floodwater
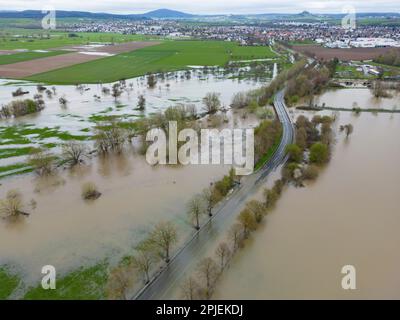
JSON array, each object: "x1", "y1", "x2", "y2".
[{"x1": 27, "y1": 41, "x2": 275, "y2": 84}]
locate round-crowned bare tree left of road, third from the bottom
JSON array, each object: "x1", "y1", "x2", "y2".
[{"x1": 150, "y1": 222, "x2": 178, "y2": 263}]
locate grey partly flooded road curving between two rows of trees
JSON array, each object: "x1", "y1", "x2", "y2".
[{"x1": 134, "y1": 91, "x2": 294, "y2": 300}]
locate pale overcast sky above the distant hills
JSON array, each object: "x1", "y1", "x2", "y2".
[{"x1": 0, "y1": 0, "x2": 400, "y2": 14}]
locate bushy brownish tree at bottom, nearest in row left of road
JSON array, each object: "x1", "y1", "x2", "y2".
[{"x1": 106, "y1": 265, "x2": 136, "y2": 300}]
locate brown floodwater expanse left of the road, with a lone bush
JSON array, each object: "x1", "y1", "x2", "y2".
[{"x1": 0, "y1": 152, "x2": 233, "y2": 288}]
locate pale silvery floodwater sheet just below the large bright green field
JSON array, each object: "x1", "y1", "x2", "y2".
[{"x1": 0, "y1": 69, "x2": 266, "y2": 135}]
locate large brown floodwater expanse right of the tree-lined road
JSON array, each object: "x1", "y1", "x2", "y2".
[{"x1": 214, "y1": 96, "x2": 400, "y2": 299}]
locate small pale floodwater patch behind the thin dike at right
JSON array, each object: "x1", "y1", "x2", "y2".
[{"x1": 314, "y1": 88, "x2": 400, "y2": 110}]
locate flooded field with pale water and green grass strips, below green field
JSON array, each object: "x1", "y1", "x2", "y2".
[{"x1": 0, "y1": 65, "x2": 272, "y2": 174}]
